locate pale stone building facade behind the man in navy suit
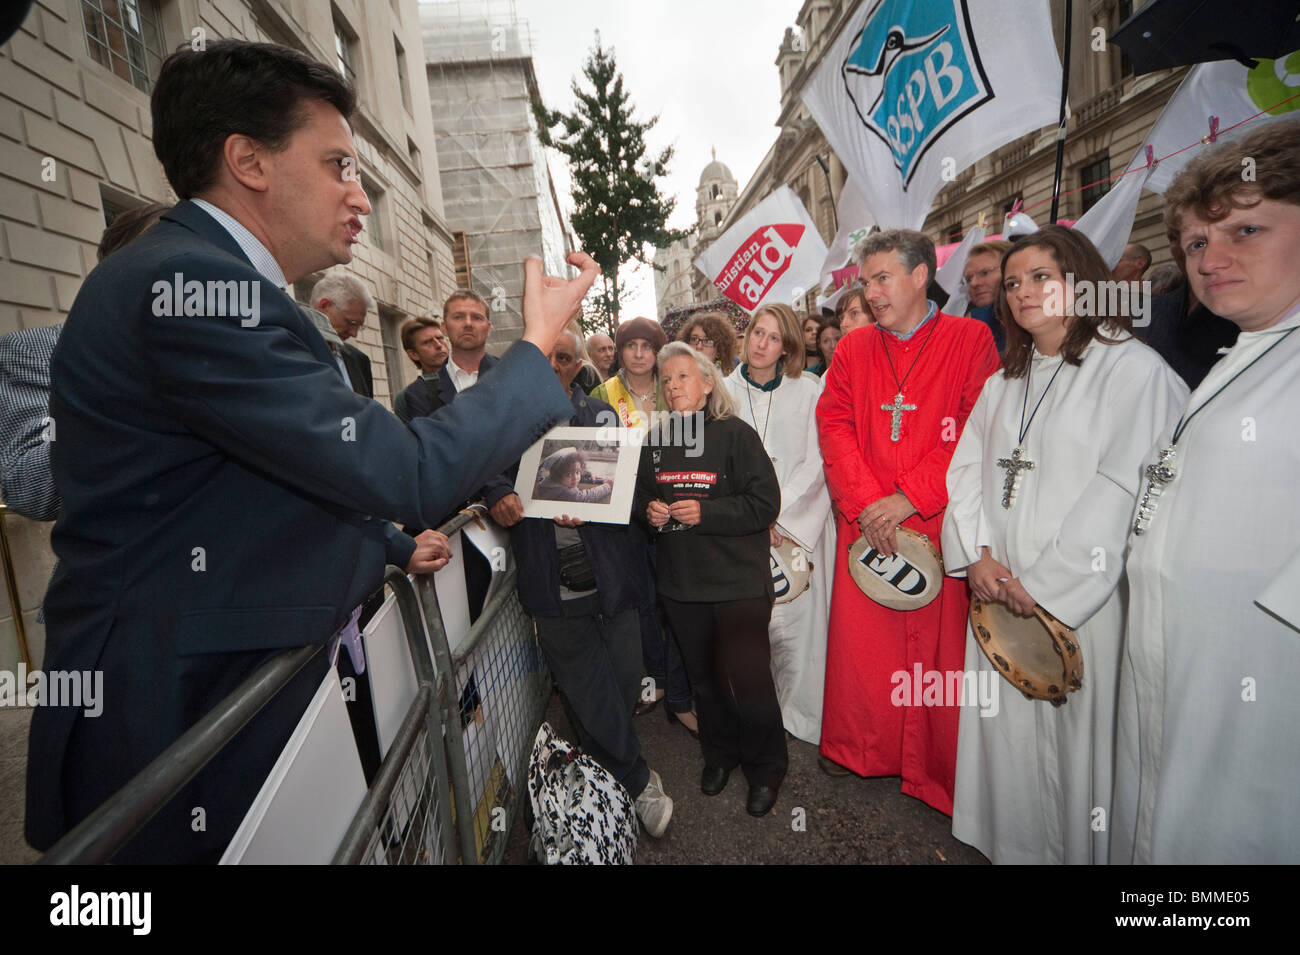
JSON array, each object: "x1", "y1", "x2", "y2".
[{"x1": 0, "y1": 0, "x2": 455, "y2": 669}]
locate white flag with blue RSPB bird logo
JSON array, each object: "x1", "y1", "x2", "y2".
[{"x1": 803, "y1": 0, "x2": 1061, "y2": 229}]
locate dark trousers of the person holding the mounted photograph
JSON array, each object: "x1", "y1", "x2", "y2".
[{"x1": 534, "y1": 605, "x2": 650, "y2": 799}]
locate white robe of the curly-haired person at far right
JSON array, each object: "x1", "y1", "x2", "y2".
[{"x1": 1112, "y1": 312, "x2": 1300, "y2": 864}]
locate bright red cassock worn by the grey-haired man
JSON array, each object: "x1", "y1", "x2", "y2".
[{"x1": 816, "y1": 312, "x2": 998, "y2": 815}]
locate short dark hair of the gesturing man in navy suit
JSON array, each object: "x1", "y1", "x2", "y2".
[{"x1": 152, "y1": 40, "x2": 356, "y2": 199}]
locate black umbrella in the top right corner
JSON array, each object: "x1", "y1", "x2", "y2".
[{"x1": 1110, "y1": 0, "x2": 1300, "y2": 73}]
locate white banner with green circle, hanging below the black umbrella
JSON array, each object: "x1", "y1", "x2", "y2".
[{"x1": 1074, "y1": 53, "x2": 1300, "y2": 268}]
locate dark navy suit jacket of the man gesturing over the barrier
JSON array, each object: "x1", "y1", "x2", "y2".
[{"x1": 27, "y1": 201, "x2": 572, "y2": 861}]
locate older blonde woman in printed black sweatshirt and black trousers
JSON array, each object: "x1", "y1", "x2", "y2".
[{"x1": 633, "y1": 342, "x2": 788, "y2": 816}]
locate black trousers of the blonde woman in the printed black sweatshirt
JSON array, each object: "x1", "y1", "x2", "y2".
[{"x1": 659, "y1": 595, "x2": 789, "y2": 787}]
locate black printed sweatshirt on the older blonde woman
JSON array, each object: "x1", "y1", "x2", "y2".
[{"x1": 632, "y1": 414, "x2": 781, "y2": 603}]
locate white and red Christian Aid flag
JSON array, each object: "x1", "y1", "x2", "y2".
[{"x1": 696, "y1": 186, "x2": 826, "y2": 314}]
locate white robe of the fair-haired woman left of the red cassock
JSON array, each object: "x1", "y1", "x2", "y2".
[{"x1": 725, "y1": 365, "x2": 835, "y2": 745}]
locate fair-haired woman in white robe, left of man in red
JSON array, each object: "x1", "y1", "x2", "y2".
[{"x1": 727, "y1": 305, "x2": 835, "y2": 745}]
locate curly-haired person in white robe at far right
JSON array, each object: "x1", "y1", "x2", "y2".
[{"x1": 1110, "y1": 125, "x2": 1300, "y2": 865}]
